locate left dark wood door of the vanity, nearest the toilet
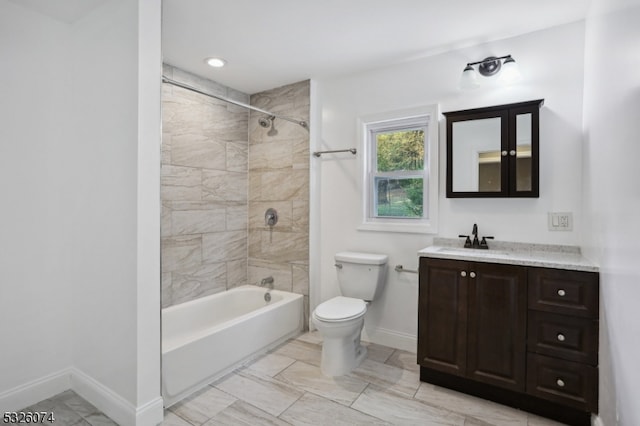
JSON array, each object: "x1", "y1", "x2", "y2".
[{"x1": 418, "y1": 257, "x2": 468, "y2": 376}]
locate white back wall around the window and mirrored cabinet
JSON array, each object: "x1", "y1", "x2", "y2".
[{"x1": 312, "y1": 22, "x2": 584, "y2": 350}]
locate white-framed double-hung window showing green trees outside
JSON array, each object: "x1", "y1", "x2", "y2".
[{"x1": 360, "y1": 107, "x2": 438, "y2": 233}]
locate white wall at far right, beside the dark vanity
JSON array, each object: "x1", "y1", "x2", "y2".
[{"x1": 583, "y1": 0, "x2": 640, "y2": 425}]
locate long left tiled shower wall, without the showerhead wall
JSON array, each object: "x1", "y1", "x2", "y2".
[{"x1": 161, "y1": 65, "x2": 249, "y2": 307}]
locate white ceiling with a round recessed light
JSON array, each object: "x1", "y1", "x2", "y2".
[{"x1": 162, "y1": 0, "x2": 590, "y2": 94}]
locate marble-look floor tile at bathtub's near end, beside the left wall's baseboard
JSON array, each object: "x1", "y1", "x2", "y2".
[{"x1": 169, "y1": 386, "x2": 236, "y2": 425}]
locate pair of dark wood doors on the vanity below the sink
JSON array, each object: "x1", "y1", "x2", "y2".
[{"x1": 418, "y1": 258, "x2": 527, "y2": 391}]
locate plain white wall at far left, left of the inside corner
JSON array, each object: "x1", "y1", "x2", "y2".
[{"x1": 0, "y1": 0, "x2": 72, "y2": 406}]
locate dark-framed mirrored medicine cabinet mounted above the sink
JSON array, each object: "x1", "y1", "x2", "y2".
[{"x1": 444, "y1": 99, "x2": 544, "y2": 198}]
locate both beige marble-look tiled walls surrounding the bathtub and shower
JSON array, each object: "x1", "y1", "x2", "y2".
[{"x1": 161, "y1": 65, "x2": 310, "y2": 328}]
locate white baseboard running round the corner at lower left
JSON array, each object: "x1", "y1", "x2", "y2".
[{"x1": 0, "y1": 367, "x2": 164, "y2": 426}]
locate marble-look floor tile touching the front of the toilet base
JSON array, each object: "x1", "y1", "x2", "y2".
[{"x1": 276, "y1": 361, "x2": 368, "y2": 405}]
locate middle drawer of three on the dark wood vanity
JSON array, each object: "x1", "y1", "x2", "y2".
[{"x1": 527, "y1": 311, "x2": 598, "y2": 365}]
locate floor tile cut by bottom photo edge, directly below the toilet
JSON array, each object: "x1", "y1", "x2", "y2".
[{"x1": 280, "y1": 393, "x2": 390, "y2": 426}]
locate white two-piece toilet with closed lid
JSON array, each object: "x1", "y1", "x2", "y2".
[{"x1": 311, "y1": 252, "x2": 388, "y2": 376}]
